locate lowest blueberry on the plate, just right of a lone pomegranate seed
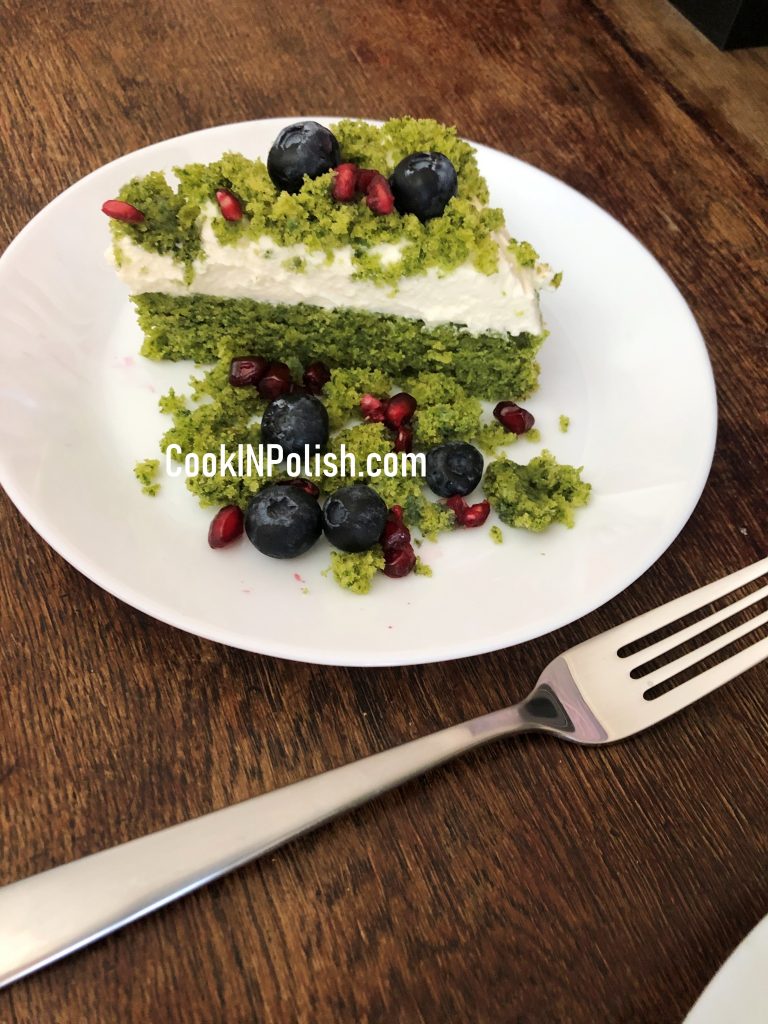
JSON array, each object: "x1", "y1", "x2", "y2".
[{"x1": 246, "y1": 483, "x2": 323, "y2": 558}]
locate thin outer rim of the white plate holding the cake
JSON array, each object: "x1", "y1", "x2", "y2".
[{"x1": 0, "y1": 115, "x2": 718, "y2": 668}]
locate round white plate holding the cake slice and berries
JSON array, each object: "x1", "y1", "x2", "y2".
[{"x1": 0, "y1": 118, "x2": 716, "y2": 666}]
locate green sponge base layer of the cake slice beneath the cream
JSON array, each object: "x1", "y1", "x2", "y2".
[{"x1": 133, "y1": 292, "x2": 546, "y2": 399}]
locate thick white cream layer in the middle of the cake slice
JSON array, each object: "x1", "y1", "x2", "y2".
[{"x1": 109, "y1": 205, "x2": 552, "y2": 335}]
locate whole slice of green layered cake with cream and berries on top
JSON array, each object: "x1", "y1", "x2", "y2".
[{"x1": 103, "y1": 118, "x2": 559, "y2": 398}]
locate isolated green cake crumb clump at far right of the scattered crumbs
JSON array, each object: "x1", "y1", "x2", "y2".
[{"x1": 483, "y1": 451, "x2": 592, "y2": 532}]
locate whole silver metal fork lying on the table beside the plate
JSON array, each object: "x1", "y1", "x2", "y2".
[{"x1": 0, "y1": 558, "x2": 768, "y2": 987}]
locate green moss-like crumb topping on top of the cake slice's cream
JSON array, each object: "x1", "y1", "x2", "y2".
[{"x1": 113, "y1": 117, "x2": 538, "y2": 289}]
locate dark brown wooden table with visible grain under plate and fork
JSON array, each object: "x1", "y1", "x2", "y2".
[{"x1": 0, "y1": 0, "x2": 768, "y2": 1024}]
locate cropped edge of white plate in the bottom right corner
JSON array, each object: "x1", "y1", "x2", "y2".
[{"x1": 683, "y1": 918, "x2": 768, "y2": 1024}]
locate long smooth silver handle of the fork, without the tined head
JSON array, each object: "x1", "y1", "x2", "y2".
[{"x1": 0, "y1": 708, "x2": 531, "y2": 987}]
